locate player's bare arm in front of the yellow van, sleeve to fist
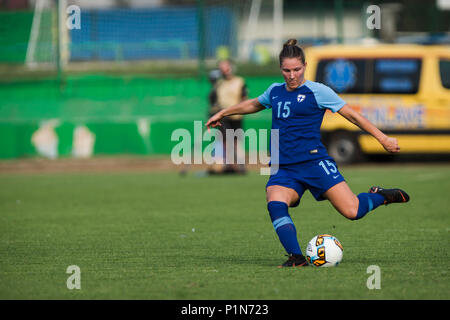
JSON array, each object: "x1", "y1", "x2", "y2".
[{"x1": 338, "y1": 104, "x2": 400, "y2": 153}]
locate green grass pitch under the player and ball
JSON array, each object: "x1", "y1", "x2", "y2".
[{"x1": 0, "y1": 165, "x2": 450, "y2": 300}]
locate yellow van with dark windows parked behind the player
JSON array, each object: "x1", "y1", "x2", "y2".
[{"x1": 305, "y1": 44, "x2": 450, "y2": 163}]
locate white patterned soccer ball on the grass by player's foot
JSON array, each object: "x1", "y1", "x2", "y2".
[{"x1": 306, "y1": 234, "x2": 344, "y2": 267}]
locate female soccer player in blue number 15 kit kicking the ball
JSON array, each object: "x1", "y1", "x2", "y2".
[{"x1": 206, "y1": 39, "x2": 409, "y2": 267}]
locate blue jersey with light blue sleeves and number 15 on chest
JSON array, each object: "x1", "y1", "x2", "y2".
[{"x1": 258, "y1": 80, "x2": 345, "y2": 165}]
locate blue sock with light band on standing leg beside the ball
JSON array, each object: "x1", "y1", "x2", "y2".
[{"x1": 267, "y1": 201, "x2": 302, "y2": 254}]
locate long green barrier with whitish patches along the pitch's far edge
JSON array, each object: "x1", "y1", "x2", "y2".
[{"x1": 0, "y1": 75, "x2": 279, "y2": 159}]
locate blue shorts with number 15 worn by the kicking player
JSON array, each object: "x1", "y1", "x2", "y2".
[{"x1": 266, "y1": 158, "x2": 345, "y2": 207}]
